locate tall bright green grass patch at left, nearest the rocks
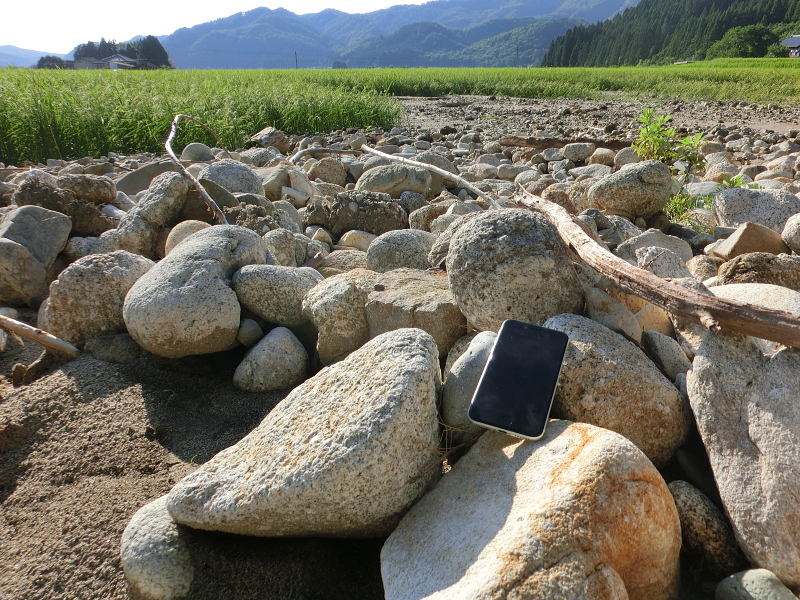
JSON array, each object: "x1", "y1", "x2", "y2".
[{"x1": 0, "y1": 69, "x2": 400, "y2": 164}]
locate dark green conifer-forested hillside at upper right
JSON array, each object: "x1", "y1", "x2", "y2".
[{"x1": 542, "y1": 0, "x2": 800, "y2": 67}]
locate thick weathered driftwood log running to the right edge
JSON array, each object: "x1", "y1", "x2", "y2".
[{"x1": 519, "y1": 192, "x2": 800, "y2": 348}]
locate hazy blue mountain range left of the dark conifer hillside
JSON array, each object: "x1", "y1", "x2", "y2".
[{"x1": 159, "y1": 0, "x2": 639, "y2": 69}]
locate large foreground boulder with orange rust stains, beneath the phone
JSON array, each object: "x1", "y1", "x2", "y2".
[{"x1": 381, "y1": 421, "x2": 681, "y2": 600}]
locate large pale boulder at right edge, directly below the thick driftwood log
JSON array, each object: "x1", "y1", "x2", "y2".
[{"x1": 687, "y1": 328, "x2": 800, "y2": 586}]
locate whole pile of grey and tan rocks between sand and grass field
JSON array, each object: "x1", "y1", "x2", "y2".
[{"x1": 0, "y1": 117, "x2": 800, "y2": 600}]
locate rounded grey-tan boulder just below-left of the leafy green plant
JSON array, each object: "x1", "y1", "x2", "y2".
[{"x1": 588, "y1": 159, "x2": 672, "y2": 219}]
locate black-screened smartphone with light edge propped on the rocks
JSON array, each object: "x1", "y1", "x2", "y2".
[{"x1": 467, "y1": 319, "x2": 569, "y2": 440}]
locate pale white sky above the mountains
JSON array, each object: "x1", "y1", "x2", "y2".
[{"x1": 0, "y1": 0, "x2": 425, "y2": 54}]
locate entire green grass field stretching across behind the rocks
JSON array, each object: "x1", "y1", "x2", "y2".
[{"x1": 0, "y1": 59, "x2": 800, "y2": 164}]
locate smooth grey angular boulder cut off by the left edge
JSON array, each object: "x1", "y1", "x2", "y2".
[{"x1": 0, "y1": 206, "x2": 72, "y2": 306}]
